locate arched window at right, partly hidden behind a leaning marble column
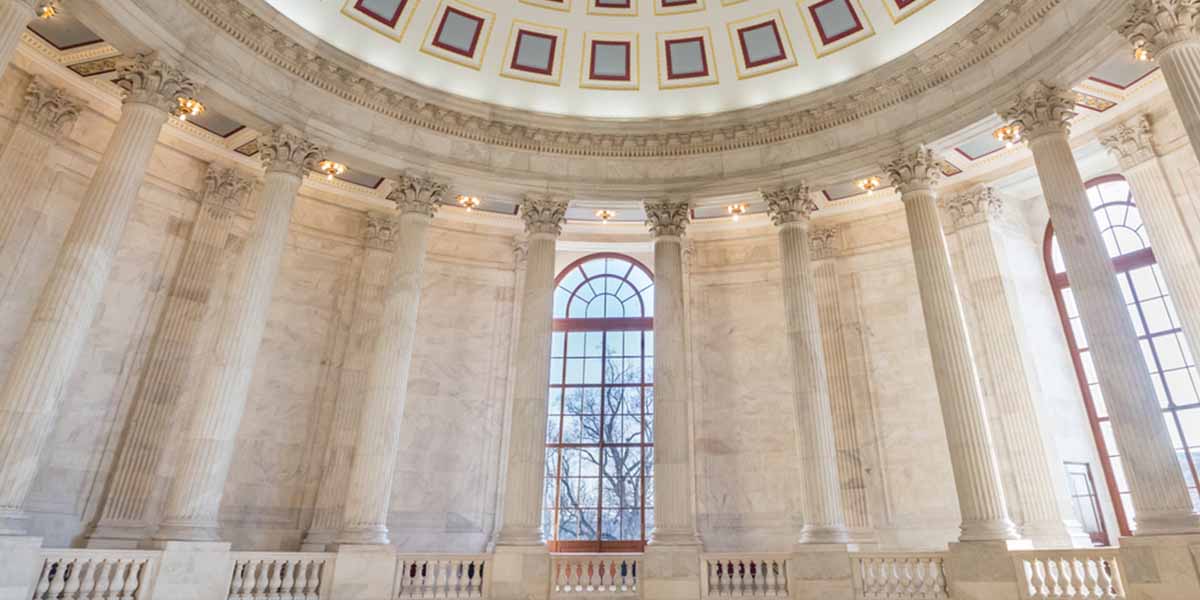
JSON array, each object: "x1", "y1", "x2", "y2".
[{"x1": 1045, "y1": 175, "x2": 1200, "y2": 535}]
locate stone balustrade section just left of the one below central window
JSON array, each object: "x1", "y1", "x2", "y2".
[{"x1": 392, "y1": 554, "x2": 488, "y2": 599}]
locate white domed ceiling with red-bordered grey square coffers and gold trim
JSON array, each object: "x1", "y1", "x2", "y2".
[{"x1": 266, "y1": 0, "x2": 983, "y2": 119}]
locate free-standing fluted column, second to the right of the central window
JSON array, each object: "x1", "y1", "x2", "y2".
[{"x1": 763, "y1": 184, "x2": 848, "y2": 544}]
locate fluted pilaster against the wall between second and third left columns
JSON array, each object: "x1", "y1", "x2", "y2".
[{"x1": 88, "y1": 166, "x2": 254, "y2": 547}]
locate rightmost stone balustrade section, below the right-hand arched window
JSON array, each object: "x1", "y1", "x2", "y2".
[{"x1": 1013, "y1": 548, "x2": 1126, "y2": 600}]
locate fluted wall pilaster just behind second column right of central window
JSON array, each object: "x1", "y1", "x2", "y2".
[{"x1": 809, "y1": 227, "x2": 876, "y2": 542}]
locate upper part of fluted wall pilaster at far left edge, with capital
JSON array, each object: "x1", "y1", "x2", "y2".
[{"x1": 0, "y1": 77, "x2": 83, "y2": 285}]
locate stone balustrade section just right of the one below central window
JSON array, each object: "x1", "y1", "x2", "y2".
[{"x1": 701, "y1": 553, "x2": 790, "y2": 598}]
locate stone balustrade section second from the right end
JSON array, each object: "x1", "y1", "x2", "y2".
[{"x1": 851, "y1": 552, "x2": 949, "y2": 600}]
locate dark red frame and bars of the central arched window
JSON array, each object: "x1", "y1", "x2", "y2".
[{"x1": 542, "y1": 252, "x2": 654, "y2": 552}]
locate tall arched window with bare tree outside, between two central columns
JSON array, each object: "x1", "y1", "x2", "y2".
[{"x1": 542, "y1": 254, "x2": 654, "y2": 552}]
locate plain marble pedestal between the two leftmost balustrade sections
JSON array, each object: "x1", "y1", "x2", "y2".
[{"x1": 146, "y1": 540, "x2": 233, "y2": 600}]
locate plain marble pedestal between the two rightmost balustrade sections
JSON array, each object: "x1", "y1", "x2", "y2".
[{"x1": 946, "y1": 540, "x2": 1033, "y2": 600}]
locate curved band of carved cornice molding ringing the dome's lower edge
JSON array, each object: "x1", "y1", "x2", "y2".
[{"x1": 175, "y1": 0, "x2": 1063, "y2": 157}]
